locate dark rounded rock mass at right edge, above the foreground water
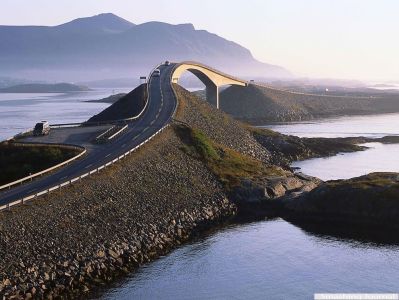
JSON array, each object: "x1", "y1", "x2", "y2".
[{"x1": 282, "y1": 173, "x2": 399, "y2": 229}]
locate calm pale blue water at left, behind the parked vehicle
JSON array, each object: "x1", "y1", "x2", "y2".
[{"x1": 0, "y1": 88, "x2": 129, "y2": 141}]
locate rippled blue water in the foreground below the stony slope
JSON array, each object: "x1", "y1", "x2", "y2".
[{"x1": 103, "y1": 220, "x2": 399, "y2": 299}]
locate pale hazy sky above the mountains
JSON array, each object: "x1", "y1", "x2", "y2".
[{"x1": 0, "y1": 0, "x2": 399, "y2": 81}]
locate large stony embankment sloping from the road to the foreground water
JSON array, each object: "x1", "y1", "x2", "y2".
[{"x1": 0, "y1": 85, "x2": 396, "y2": 299}]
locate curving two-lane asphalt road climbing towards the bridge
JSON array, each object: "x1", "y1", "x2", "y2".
[{"x1": 0, "y1": 64, "x2": 176, "y2": 205}]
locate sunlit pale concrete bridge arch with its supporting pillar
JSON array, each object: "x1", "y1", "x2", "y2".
[{"x1": 172, "y1": 62, "x2": 248, "y2": 108}]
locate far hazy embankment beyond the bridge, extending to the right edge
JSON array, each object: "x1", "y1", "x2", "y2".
[{"x1": 220, "y1": 84, "x2": 399, "y2": 125}]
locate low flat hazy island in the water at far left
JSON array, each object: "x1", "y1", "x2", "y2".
[{"x1": 0, "y1": 83, "x2": 90, "y2": 93}]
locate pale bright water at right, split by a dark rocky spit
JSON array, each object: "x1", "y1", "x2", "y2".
[{"x1": 267, "y1": 114, "x2": 399, "y2": 180}]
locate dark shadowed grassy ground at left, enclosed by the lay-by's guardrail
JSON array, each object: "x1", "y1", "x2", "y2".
[{"x1": 0, "y1": 142, "x2": 80, "y2": 185}]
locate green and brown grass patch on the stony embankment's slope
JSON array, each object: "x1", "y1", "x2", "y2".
[{"x1": 175, "y1": 126, "x2": 285, "y2": 189}]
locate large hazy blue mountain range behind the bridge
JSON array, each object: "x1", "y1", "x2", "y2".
[{"x1": 0, "y1": 14, "x2": 291, "y2": 82}]
